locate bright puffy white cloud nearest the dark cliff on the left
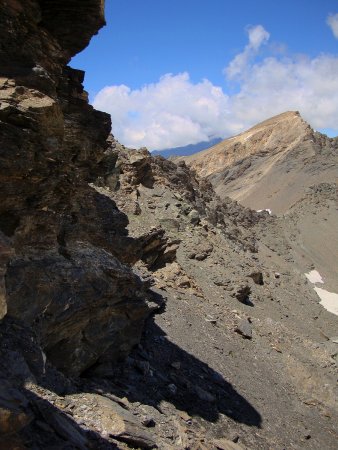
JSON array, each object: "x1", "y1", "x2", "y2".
[{"x1": 94, "y1": 72, "x2": 232, "y2": 149}]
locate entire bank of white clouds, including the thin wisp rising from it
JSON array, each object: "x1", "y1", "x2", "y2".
[{"x1": 94, "y1": 25, "x2": 338, "y2": 150}]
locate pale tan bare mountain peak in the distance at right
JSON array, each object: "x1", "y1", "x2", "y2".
[{"x1": 181, "y1": 111, "x2": 338, "y2": 214}]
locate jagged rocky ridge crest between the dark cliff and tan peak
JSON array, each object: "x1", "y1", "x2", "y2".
[{"x1": 98, "y1": 143, "x2": 269, "y2": 252}]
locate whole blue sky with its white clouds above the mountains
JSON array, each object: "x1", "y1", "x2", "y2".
[{"x1": 71, "y1": 0, "x2": 338, "y2": 149}]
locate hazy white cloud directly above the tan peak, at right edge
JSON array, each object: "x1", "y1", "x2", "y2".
[{"x1": 229, "y1": 55, "x2": 338, "y2": 129}]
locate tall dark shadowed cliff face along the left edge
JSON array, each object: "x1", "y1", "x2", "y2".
[{"x1": 0, "y1": 0, "x2": 149, "y2": 375}]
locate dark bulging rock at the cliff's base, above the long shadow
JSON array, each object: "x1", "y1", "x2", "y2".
[{"x1": 7, "y1": 245, "x2": 150, "y2": 375}]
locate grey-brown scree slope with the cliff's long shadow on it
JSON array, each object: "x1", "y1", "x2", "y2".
[{"x1": 84, "y1": 146, "x2": 337, "y2": 449}]
